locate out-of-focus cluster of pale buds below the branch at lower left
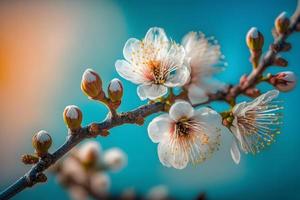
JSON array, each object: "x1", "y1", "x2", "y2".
[{"x1": 52, "y1": 141, "x2": 127, "y2": 200}]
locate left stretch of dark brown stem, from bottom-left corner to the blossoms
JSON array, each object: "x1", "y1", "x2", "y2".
[{"x1": 0, "y1": 103, "x2": 164, "y2": 200}]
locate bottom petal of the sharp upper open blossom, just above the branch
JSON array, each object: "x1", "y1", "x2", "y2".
[{"x1": 137, "y1": 84, "x2": 168, "y2": 100}]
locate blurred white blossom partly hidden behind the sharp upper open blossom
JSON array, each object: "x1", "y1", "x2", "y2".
[{"x1": 182, "y1": 32, "x2": 224, "y2": 104}]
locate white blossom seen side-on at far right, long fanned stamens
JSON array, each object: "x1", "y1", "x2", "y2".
[{"x1": 230, "y1": 90, "x2": 282, "y2": 164}]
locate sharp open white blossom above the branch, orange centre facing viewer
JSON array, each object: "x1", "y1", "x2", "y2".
[{"x1": 115, "y1": 27, "x2": 189, "y2": 100}]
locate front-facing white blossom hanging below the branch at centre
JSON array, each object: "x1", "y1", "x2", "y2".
[{"x1": 148, "y1": 101, "x2": 222, "y2": 169}]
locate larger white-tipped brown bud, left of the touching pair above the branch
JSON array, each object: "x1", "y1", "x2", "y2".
[{"x1": 81, "y1": 69, "x2": 103, "y2": 99}]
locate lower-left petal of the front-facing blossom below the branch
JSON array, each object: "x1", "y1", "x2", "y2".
[{"x1": 157, "y1": 141, "x2": 173, "y2": 167}]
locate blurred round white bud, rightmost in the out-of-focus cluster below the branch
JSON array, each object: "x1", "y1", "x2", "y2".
[{"x1": 103, "y1": 148, "x2": 127, "y2": 171}]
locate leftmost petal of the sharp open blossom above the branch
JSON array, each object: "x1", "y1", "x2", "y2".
[{"x1": 115, "y1": 60, "x2": 147, "y2": 84}]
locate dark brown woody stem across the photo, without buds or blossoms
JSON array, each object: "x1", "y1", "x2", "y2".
[{"x1": 0, "y1": 2, "x2": 300, "y2": 200}]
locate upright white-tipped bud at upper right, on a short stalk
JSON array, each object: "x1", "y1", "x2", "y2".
[{"x1": 246, "y1": 27, "x2": 264, "y2": 51}]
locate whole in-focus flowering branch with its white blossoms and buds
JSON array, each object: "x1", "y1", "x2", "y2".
[{"x1": 0, "y1": 2, "x2": 300, "y2": 199}]
